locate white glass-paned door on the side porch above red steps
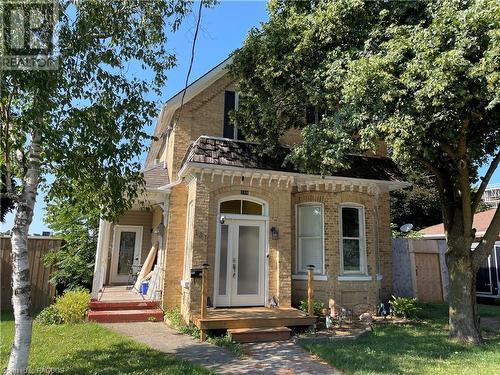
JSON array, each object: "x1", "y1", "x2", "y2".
[{"x1": 109, "y1": 225, "x2": 142, "y2": 283}]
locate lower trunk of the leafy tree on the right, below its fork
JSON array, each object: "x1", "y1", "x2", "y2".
[{"x1": 446, "y1": 241, "x2": 482, "y2": 344}]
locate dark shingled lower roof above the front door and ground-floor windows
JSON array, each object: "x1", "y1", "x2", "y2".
[{"x1": 183, "y1": 137, "x2": 404, "y2": 182}]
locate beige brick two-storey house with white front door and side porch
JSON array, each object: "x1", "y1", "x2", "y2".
[{"x1": 92, "y1": 59, "x2": 408, "y2": 334}]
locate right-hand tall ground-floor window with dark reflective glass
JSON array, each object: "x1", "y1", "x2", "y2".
[{"x1": 340, "y1": 205, "x2": 367, "y2": 274}]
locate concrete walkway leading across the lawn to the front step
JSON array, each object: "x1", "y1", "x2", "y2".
[{"x1": 103, "y1": 322, "x2": 341, "y2": 375}]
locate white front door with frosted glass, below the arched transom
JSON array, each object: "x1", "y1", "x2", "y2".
[{"x1": 215, "y1": 219, "x2": 266, "y2": 307}]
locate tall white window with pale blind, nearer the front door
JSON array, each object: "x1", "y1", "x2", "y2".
[{"x1": 296, "y1": 203, "x2": 324, "y2": 274}]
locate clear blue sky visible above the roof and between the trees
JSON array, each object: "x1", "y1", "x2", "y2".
[{"x1": 1, "y1": 0, "x2": 500, "y2": 233}]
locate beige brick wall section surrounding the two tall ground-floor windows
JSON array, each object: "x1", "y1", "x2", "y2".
[{"x1": 292, "y1": 185, "x2": 392, "y2": 307}]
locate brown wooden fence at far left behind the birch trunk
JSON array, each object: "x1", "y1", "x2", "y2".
[{"x1": 0, "y1": 236, "x2": 62, "y2": 311}]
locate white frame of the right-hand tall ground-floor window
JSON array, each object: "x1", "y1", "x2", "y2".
[{"x1": 339, "y1": 203, "x2": 368, "y2": 276}]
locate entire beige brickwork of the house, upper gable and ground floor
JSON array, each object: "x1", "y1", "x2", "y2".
[{"x1": 145, "y1": 68, "x2": 392, "y2": 318}]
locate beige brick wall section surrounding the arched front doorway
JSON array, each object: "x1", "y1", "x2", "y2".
[{"x1": 182, "y1": 176, "x2": 291, "y2": 324}]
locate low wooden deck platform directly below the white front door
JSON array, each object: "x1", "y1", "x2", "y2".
[{"x1": 193, "y1": 307, "x2": 316, "y2": 329}]
